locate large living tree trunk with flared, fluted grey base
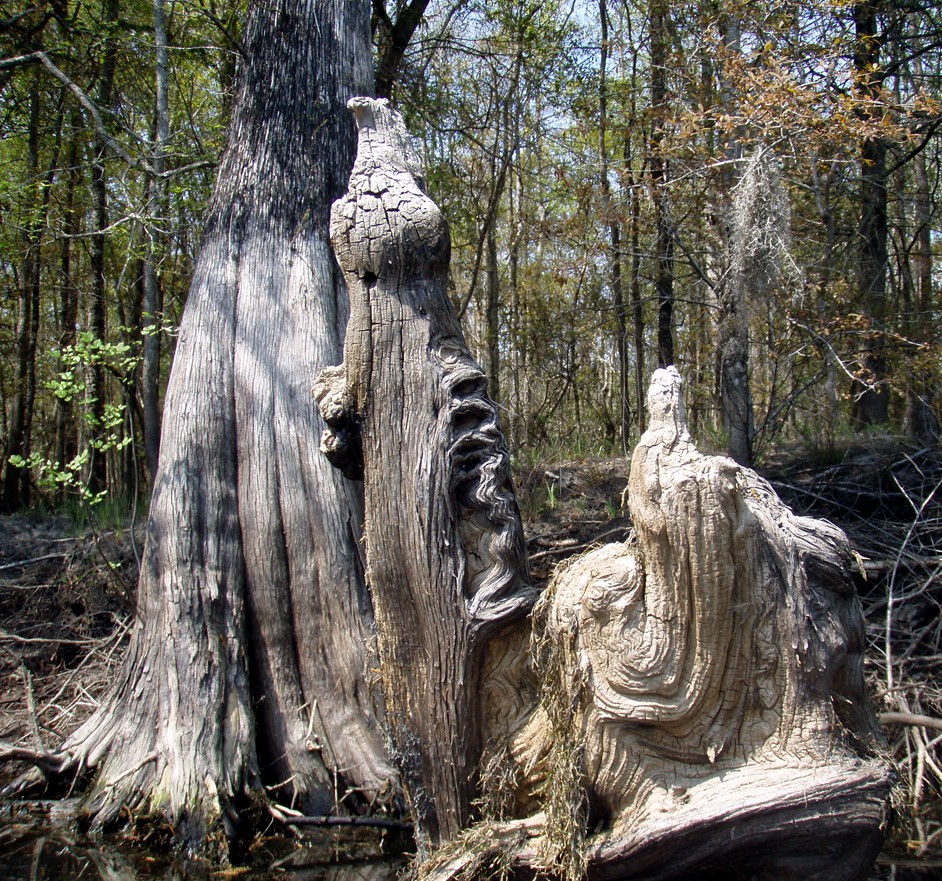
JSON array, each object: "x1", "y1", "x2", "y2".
[{"x1": 56, "y1": 0, "x2": 396, "y2": 841}]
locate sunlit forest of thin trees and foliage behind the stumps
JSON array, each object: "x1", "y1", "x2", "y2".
[{"x1": 0, "y1": 0, "x2": 942, "y2": 511}]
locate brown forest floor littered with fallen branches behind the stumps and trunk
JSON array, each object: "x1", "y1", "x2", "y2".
[{"x1": 0, "y1": 439, "x2": 942, "y2": 877}]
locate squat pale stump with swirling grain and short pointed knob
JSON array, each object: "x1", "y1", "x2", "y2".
[{"x1": 515, "y1": 368, "x2": 891, "y2": 881}]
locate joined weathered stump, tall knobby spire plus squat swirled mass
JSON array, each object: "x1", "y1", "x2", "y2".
[{"x1": 315, "y1": 99, "x2": 891, "y2": 881}]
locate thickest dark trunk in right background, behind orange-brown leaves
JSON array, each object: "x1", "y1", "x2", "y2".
[{"x1": 853, "y1": 2, "x2": 890, "y2": 428}]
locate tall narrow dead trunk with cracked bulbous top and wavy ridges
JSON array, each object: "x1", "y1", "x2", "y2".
[{"x1": 315, "y1": 98, "x2": 534, "y2": 852}]
